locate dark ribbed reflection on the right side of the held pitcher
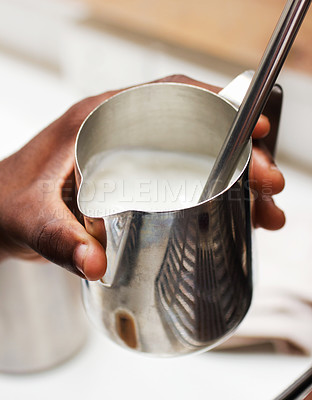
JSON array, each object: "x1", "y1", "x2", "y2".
[{"x1": 156, "y1": 175, "x2": 251, "y2": 347}]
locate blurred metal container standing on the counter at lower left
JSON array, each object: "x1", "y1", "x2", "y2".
[{"x1": 0, "y1": 259, "x2": 87, "y2": 373}]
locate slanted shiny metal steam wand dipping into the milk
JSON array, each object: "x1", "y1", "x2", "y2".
[{"x1": 199, "y1": 0, "x2": 311, "y2": 202}]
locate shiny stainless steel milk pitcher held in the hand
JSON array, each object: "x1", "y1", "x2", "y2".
[{"x1": 76, "y1": 72, "x2": 282, "y2": 356}]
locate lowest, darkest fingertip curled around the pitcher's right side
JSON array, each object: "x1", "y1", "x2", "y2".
[{"x1": 255, "y1": 196, "x2": 286, "y2": 230}]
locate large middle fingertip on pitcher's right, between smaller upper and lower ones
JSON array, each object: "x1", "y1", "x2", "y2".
[{"x1": 250, "y1": 146, "x2": 285, "y2": 196}]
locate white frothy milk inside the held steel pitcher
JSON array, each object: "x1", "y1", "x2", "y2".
[{"x1": 80, "y1": 148, "x2": 239, "y2": 217}]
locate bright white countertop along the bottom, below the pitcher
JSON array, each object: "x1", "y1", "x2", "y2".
[{"x1": 0, "y1": 330, "x2": 311, "y2": 400}]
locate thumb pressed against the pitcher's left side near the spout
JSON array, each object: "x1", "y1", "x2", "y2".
[{"x1": 31, "y1": 199, "x2": 107, "y2": 280}]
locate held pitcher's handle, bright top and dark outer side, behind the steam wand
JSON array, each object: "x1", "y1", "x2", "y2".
[{"x1": 218, "y1": 70, "x2": 283, "y2": 158}]
